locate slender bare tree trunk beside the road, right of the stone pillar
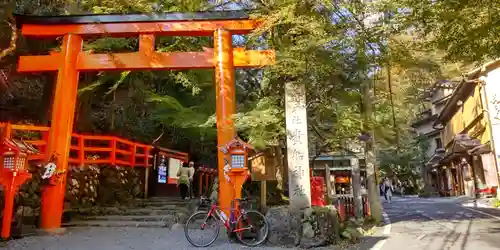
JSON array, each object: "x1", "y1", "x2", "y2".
[{"x1": 363, "y1": 80, "x2": 382, "y2": 223}]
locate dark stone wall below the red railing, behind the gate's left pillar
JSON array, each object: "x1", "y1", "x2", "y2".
[{"x1": 0, "y1": 165, "x2": 145, "y2": 231}]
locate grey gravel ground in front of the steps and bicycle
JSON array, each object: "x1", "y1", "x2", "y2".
[{"x1": 0, "y1": 227, "x2": 378, "y2": 250}]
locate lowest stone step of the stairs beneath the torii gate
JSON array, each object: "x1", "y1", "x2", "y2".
[{"x1": 63, "y1": 220, "x2": 168, "y2": 228}]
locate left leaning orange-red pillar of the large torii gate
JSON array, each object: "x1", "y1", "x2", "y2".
[{"x1": 40, "y1": 34, "x2": 83, "y2": 231}]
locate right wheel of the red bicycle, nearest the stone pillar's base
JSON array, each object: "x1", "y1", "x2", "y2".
[{"x1": 234, "y1": 210, "x2": 269, "y2": 247}]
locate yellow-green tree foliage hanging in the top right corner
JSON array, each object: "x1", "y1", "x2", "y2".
[{"x1": 382, "y1": 0, "x2": 500, "y2": 63}]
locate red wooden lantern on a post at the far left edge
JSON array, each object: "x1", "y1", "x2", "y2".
[{"x1": 0, "y1": 137, "x2": 39, "y2": 239}]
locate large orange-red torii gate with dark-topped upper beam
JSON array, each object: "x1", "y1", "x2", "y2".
[{"x1": 16, "y1": 11, "x2": 275, "y2": 231}]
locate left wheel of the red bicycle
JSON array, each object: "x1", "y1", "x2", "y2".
[{"x1": 184, "y1": 211, "x2": 220, "y2": 247}]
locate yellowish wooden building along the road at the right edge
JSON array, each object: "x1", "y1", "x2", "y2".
[{"x1": 431, "y1": 65, "x2": 500, "y2": 196}]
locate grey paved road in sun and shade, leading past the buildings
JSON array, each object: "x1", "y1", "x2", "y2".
[{"x1": 381, "y1": 198, "x2": 500, "y2": 250}]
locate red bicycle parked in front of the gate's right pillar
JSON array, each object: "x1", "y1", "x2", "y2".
[{"x1": 184, "y1": 198, "x2": 269, "y2": 247}]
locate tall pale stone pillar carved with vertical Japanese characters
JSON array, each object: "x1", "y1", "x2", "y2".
[{"x1": 285, "y1": 83, "x2": 311, "y2": 209}]
